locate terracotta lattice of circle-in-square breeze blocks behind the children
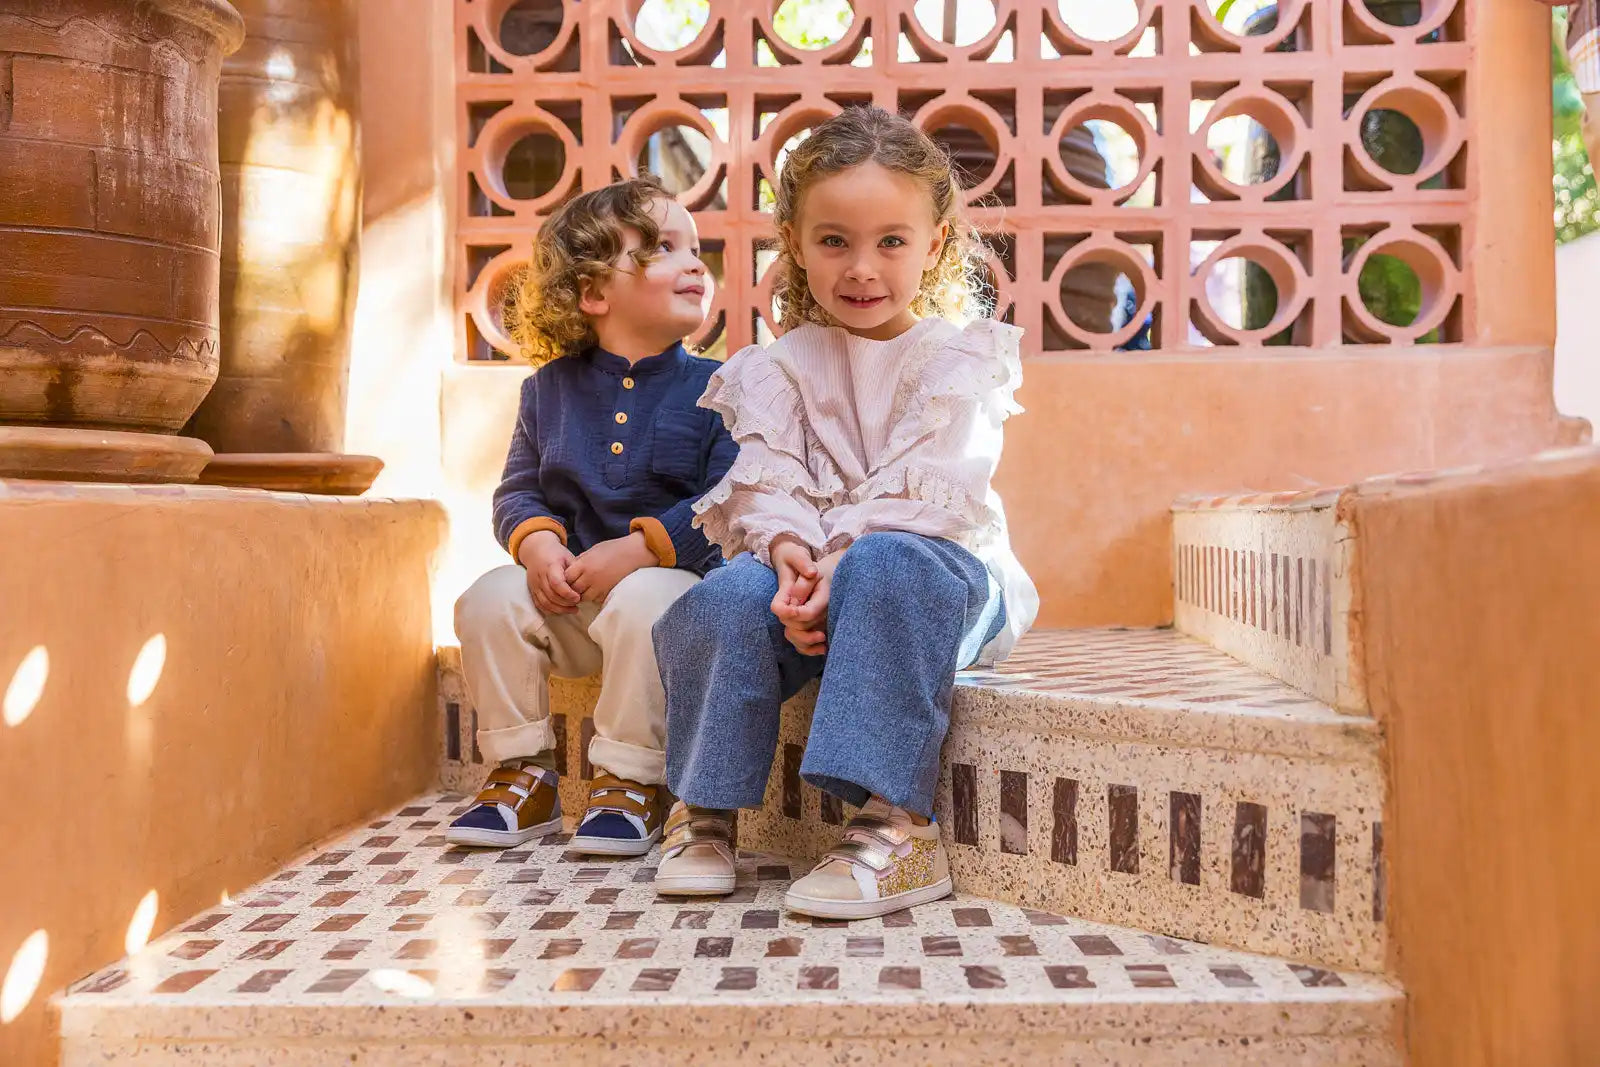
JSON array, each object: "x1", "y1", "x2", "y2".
[{"x1": 454, "y1": 0, "x2": 1480, "y2": 358}]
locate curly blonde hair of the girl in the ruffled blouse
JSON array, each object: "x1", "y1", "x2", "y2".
[{"x1": 773, "y1": 107, "x2": 982, "y2": 330}]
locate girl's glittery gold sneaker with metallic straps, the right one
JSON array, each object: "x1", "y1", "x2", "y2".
[{"x1": 784, "y1": 800, "x2": 950, "y2": 918}]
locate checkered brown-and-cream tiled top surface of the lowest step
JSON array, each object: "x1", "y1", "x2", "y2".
[{"x1": 67, "y1": 795, "x2": 1387, "y2": 1009}]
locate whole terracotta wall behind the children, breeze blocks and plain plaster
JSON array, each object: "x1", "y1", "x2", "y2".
[{"x1": 440, "y1": 0, "x2": 1558, "y2": 625}]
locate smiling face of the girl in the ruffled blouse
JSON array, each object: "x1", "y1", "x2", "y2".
[{"x1": 784, "y1": 163, "x2": 949, "y2": 341}]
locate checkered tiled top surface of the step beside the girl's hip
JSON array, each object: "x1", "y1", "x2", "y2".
[{"x1": 960, "y1": 630, "x2": 1326, "y2": 715}]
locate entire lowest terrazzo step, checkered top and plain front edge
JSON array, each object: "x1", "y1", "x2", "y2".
[{"x1": 58, "y1": 793, "x2": 1403, "y2": 1067}]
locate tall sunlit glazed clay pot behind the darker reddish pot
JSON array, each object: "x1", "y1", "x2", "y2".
[{"x1": 192, "y1": 0, "x2": 360, "y2": 453}]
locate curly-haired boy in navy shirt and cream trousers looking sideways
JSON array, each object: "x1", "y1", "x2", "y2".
[{"x1": 446, "y1": 178, "x2": 738, "y2": 856}]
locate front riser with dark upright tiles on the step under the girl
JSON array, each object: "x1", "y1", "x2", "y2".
[{"x1": 739, "y1": 689, "x2": 1384, "y2": 971}]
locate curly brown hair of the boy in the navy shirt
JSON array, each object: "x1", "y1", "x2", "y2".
[{"x1": 506, "y1": 174, "x2": 672, "y2": 366}]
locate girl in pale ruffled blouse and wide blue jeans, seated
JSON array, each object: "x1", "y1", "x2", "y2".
[{"x1": 654, "y1": 107, "x2": 1038, "y2": 918}]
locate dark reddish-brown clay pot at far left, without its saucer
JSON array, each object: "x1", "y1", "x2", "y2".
[{"x1": 0, "y1": 0, "x2": 245, "y2": 432}]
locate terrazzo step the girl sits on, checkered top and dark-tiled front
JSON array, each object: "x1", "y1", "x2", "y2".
[{"x1": 739, "y1": 630, "x2": 1386, "y2": 971}]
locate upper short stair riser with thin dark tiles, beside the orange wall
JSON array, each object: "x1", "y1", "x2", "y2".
[{"x1": 1173, "y1": 493, "x2": 1366, "y2": 715}]
